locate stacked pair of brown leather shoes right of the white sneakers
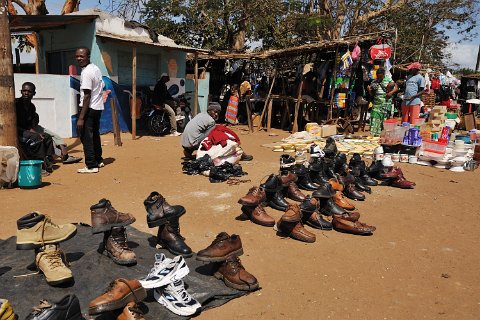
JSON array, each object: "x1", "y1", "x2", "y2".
[{"x1": 196, "y1": 232, "x2": 259, "y2": 291}]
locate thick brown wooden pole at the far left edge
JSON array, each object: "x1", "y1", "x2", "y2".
[{"x1": 0, "y1": 0, "x2": 17, "y2": 147}]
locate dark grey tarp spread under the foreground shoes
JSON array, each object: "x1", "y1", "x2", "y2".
[{"x1": 0, "y1": 225, "x2": 246, "y2": 319}]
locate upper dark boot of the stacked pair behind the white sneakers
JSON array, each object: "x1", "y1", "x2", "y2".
[{"x1": 143, "y1": 191, "x2": 186, "y2": 228}]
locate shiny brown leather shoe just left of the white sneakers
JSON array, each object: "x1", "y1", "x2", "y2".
[{"x1": 88, "y1": 278, "x2": 147, "y2": 315}]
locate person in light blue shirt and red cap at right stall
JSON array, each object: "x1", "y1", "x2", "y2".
[{"x1": 402, "y1": 62, "x2": 425, "y2": 123}]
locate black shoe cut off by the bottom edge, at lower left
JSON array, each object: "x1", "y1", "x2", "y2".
[{"x1": 26, "y1": 294, "x2": 83, "y2": 320}]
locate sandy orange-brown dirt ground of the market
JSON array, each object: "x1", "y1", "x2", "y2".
[{"x1": 0, "y1": 126, "x2": 480, "y2": 319}]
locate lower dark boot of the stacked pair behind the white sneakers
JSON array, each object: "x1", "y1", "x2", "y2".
[{"x1": 157, "y1": 218, "x2": 193, "y2": 257}]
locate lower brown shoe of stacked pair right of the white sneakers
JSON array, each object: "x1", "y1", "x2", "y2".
[{"x1": 214, "y1": 257, "x2": 259, "y2": 291}]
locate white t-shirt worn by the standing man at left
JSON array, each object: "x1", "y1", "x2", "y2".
[{"x1": 80, "y1": 63, "x2": 104, "y2": 110}]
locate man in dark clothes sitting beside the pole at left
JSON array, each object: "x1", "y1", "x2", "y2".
[{"x1": 15, "y1": 82, "x2": 55, "y2": 173}]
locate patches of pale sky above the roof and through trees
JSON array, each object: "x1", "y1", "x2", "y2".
[{"x1": 10, "y1": 0, "x2": 480, "y2": 69}]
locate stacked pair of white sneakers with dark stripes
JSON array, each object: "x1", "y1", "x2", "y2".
[{"x1": 140, "y1": 253, "x2": 202, "y2": 316}]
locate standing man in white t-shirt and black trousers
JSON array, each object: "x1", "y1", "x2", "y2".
[{"x1": 75, "y1": 47, "x2": 104, "y2": 173}]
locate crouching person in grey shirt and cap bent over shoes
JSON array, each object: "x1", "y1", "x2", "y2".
[{"x1": 182, "y1": 102, "x2": 253, "y2": 161}]
